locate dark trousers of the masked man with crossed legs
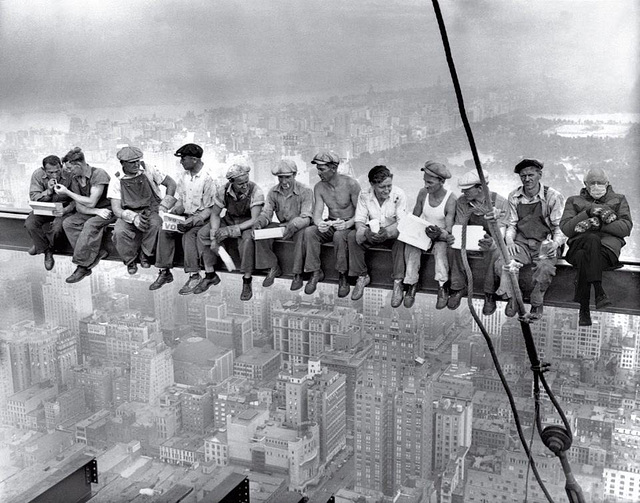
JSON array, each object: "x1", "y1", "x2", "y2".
[{"x1": 565, "y1": 232, "x2": 618, "y2": 301}]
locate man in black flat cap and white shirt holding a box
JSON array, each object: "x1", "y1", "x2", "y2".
[{"x1": 149, "y1": 143, "x2": 216, "y2": 295}]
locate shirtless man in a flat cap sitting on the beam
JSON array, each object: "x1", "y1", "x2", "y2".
[{"x1": 304, "y1": 152, "x2": 360, "y2": 297}]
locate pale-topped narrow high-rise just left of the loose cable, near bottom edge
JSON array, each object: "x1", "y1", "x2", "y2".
[{"x1": 433, "y1": 398, "x2": 473, "y2": 473}]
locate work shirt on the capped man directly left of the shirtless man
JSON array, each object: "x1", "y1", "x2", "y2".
[{"x1": 258, "y1": 181, "x2": 313, "y2": 230}]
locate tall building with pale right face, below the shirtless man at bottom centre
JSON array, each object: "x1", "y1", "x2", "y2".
[{"x1": 307, "y1": 369, "x2": 347, "y2": 463}]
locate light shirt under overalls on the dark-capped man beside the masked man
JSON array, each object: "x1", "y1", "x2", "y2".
[{"x1": 505, "y1": 183, "x2": 567, "y2": 247}]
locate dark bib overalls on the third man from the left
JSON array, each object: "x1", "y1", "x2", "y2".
[{"x1": 113, "y1": 173, "x2": 162, "y2": 265}]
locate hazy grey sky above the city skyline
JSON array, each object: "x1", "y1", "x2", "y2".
[{"x1": 0, "y1": 0, "x2": 640, "y2": 111}]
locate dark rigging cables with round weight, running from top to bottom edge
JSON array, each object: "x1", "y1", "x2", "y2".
[{"x1": 432, "y1": 0, "x2": 584, "y2": 503}]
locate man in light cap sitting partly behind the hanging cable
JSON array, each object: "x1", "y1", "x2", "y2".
[{"x1": 447, "y1": 169, "x2": 508, "y2": 316}]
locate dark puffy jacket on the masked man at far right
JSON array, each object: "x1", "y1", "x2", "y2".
[{"x1": 560, "y1": 186, "x2": 633, "y2": 257}]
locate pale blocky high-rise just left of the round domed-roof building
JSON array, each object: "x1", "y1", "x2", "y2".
[{"x1": 130, "y1": 342, "x2": 174, "y2": 405}]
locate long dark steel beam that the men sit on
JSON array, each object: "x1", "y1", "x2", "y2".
[{"x1": 0, "y1": 210, "x2": 640, "y2": 315}]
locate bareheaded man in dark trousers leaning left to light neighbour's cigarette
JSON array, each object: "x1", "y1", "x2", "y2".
[{"x1": 54, "y1": 147, "x2": 116, "y2": 283}]
